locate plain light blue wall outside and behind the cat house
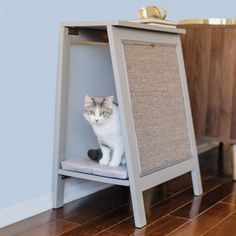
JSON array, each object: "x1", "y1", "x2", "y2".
[{"x1": 0, "y1": 0, "x2": 236, "y2": 209}]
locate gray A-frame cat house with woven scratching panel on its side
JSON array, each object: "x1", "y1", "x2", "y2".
[{"x1": 54, "y1": 21, "x2": 202, "y2": 227}]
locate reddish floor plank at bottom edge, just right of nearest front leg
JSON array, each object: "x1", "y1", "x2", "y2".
[{"x1": 134, "y1": 216, "x2": 188, "y2": 236}]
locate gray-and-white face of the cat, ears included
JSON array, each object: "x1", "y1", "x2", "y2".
[{"x1": 83, "y1": 95, "x2": 113, "y2": 125}]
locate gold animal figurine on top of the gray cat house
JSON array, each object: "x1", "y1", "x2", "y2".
[{"x1": 138, "y1": 6, "x2": 167, "y2": 20}]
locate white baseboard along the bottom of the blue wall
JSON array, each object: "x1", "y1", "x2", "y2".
[{"x1": 0, "y1": 179, "x2": 111, "y2": 228}]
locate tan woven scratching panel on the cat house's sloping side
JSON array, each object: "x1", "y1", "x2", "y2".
[{"x1": 123, "y1": 40, "x2": 192, "y2": 175}]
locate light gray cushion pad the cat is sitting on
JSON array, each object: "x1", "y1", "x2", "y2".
[{"x1": 61, "y1": 158, "x2": 128, "y2": 179}]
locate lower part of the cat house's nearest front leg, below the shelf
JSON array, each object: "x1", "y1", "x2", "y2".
[{"x1": 130, "y1": 186, "x2": 147, "y2": 228}]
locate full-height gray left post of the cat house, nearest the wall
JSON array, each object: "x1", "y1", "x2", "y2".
[{"x1": 53, "y1": 26, "x2": 71, "y2": 208}]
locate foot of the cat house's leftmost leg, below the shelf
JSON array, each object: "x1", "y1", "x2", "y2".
[{"x1": 53, "y1": 175, "x2": 64, "y2": 209}]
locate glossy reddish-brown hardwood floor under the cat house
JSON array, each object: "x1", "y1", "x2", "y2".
[{"x1": 0, "y1": 149, "x2": 236, "y2": 236}]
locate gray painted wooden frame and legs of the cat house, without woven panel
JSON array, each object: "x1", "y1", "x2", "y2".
[{"x1": 53, "y1": 21, "x2": 202, "y2": 228}]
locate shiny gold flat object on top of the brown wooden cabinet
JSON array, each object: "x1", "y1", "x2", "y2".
[{"x1": 179, "y1": 18, "x2": 236, "y2": 25}]
